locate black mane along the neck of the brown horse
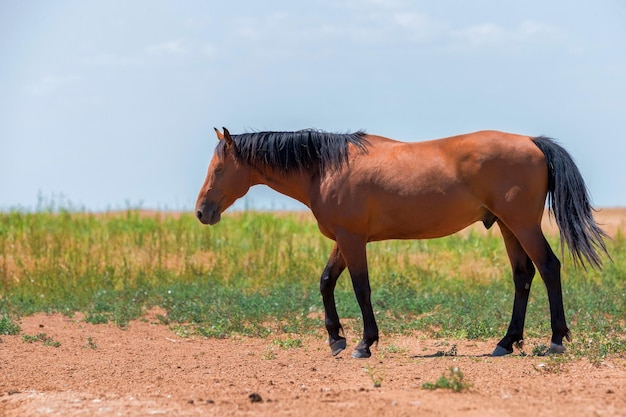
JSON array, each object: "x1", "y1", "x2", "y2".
[{"x1": 217, "y1": 129, "x2": 369, "y2": 173}]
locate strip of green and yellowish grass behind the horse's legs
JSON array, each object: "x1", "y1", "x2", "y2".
[{"x1": 0, "y1": 207, "x2": 626, "y2": 362}]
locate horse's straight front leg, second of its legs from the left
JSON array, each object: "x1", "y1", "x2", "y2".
[{"x1": 337, "y1": 233, "x2": 378, "y2": 358}]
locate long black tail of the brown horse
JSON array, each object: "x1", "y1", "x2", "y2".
[{"x1": 532, "y1": 136, "x2": 608, "y2": 269}]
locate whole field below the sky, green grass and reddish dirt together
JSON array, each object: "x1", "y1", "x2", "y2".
[{"x1": 0, "y1": 208, "x2": 626, "y2": 416}]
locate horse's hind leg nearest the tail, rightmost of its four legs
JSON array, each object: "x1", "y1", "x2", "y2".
[{"x1": 516, "y1": 225, "x2": 571, "y2": 353}]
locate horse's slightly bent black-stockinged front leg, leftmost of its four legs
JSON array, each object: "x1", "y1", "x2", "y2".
[{"x1": 320, "y1": 243, "x2": 346, "y2": 356}]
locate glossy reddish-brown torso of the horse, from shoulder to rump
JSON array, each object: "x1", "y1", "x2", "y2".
[{"x1": 316, "y1": 131, "x2": 547, "y2": 240}]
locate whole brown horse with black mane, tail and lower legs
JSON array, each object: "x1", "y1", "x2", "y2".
[{"x1": 196, "y1": 128, "x2": 606, "y2": 358}]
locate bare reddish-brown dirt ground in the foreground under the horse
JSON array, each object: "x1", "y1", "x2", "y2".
[{"x1": 0, "y1": 209, "x2": 626, "y2": 417}]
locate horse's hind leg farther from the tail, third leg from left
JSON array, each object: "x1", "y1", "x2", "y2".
[{"x1": 492, "y1": 221, "x2": 535, "y2": 356}]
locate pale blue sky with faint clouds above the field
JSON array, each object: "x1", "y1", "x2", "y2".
[{"x1": 0, "y1": 0, "x2": 626, "y2": 211}]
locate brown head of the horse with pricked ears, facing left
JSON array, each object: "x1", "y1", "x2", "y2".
[{"x1": 196, "y1": 128, "x2": 250, "y2": 225}]
